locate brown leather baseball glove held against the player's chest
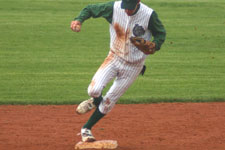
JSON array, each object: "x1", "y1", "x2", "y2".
[{"x1": 130, "y1": 37, "x2": 155, "y2": 55}]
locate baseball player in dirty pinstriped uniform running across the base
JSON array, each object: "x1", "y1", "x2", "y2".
[{"x1": 71, "y1": 0, "x2": 166, "y2": 142}]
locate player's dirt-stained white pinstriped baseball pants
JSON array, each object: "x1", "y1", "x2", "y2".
[{"x1": 88, "y1": 52, "x2": 144, "y2": 114}]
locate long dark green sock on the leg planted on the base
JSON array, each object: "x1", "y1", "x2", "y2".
[{"x1": 83, "y1": 107, "x2": 105, "y2": 129}]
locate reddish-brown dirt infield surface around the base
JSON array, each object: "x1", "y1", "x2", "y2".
[{"x1": 0, "y1": 103, "x2": 225, "y2": 150}]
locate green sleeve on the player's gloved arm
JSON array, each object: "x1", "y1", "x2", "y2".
[{"x1": 148, "y1": 11, "x2": 166, "y2": 50}]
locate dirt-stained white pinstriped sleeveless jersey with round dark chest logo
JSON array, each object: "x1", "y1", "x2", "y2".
[{"x1": 110, "y1": 1, "x2": 153, "y2": 63}]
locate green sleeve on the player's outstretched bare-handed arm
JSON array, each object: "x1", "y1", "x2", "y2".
[{"x1": 74, "y1": 1, "x2": 114, "y2": 24}]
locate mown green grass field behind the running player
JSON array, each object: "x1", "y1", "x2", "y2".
[{"x1": 0, "y1": 0, "x2": 225, "y2": 104}]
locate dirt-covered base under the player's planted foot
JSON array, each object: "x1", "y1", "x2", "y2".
[{"x1": 75, "y1": 140, "x2": 118, "y2": 150}]
